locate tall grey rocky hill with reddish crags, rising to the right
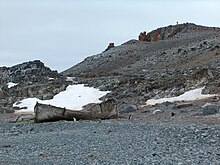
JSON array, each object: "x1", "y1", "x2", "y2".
[{"x1": 62, "y1": 23, "x2": 220, "y2": 122}]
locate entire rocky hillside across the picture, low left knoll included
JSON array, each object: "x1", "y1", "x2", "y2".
[{"x1": 0, "y1": 23, "x2": 220, "y2": 124}]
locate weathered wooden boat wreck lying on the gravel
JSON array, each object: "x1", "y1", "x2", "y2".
[{"x1": 34, "y1": 99, "x2": 118, "y2": 123}]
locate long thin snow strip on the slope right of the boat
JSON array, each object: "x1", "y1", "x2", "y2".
[{"x1": 146, "y1": 87, "x2": 217, "y2": 105}]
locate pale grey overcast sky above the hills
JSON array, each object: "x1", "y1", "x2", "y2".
[{"x1": 0, "y1": 0, "x2": 220, "y2": 71}]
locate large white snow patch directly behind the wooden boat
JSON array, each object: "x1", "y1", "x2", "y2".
[{"x1": 13, "y1": 84, "x2": 110, "y2": 113}]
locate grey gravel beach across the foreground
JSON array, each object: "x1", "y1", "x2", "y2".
[{"x1": 0, "y1": 120, "x2": 220, "y2": 165}]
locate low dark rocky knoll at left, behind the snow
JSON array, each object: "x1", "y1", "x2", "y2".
[{"x1": 0, "y1": 60, "x2": 67, "y2": 112}]
